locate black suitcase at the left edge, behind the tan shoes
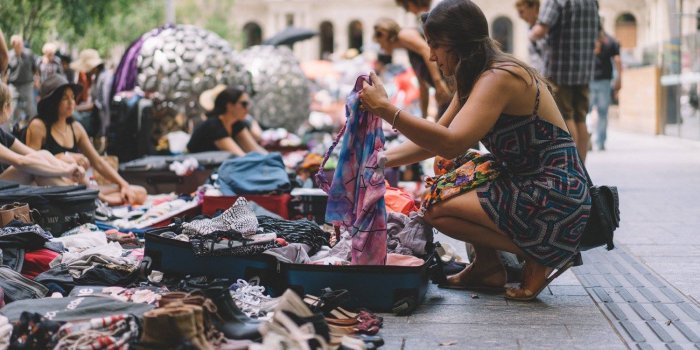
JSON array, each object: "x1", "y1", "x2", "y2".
[{"x1": 0, "y1": 185, "x2": 99, "y2": 237}]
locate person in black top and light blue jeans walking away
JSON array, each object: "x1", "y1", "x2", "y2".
[{"x1": 590, "y1": 30, "x2": 622, "y2": 151}]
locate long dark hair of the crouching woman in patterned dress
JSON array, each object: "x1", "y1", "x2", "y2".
[{"x1": 421, "y1": 0, "x2": 549, "y2": 104}]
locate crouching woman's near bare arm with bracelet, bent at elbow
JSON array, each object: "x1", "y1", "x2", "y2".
[{"x1": 361, "y1": 70, "x2": 517, "y2": 159}]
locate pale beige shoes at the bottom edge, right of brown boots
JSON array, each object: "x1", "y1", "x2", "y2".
[{"x1": 249, "y1": 289, "x2": 331, "y2": 350}]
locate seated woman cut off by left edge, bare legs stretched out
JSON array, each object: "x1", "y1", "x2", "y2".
[{"x1": 0, "y1": 81, "x2": 85, "y2": 186}]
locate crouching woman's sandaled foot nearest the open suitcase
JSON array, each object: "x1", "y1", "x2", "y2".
[{"x1": 442, "y1": 260, "x2": 507, "y2": 292}]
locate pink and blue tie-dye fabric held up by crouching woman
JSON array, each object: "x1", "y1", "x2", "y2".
[{"x1": 316, "y1": 75, "x2": 386, "y2": 265}]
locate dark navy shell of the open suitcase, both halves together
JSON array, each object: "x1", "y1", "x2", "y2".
[{"x1": 145, "y1": 227, "x2": 429, "y2": 314}]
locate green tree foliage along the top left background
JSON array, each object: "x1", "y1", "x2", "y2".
[{"x1": 0, "y1": 0, "x2": 240, "y2": 56}]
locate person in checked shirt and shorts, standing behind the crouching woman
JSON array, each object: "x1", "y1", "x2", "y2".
[{"x1": 529, "y1": 0, "x2": 600, "y2": 161}]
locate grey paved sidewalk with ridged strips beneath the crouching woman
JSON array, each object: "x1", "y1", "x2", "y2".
[{"x1": 382, "y1": 131, "x2": 700, "y2": 349}]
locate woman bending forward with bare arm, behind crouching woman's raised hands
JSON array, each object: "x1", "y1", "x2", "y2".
[{"x1": 374, "y1": 18, "x2": 452, "y2": 119}]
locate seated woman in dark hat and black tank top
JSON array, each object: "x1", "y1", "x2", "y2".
[{"x1": 27, "y1": 75, "x2": 146, "y2": 205}]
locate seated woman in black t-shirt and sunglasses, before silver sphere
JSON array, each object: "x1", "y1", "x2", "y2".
[{"x1": 187, "y1": 87, "x2": 267, "y2": 156}]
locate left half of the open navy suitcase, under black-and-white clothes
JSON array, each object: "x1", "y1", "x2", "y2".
[{"x1": 144, "y1": 227, "x2": 284, "y2": 295}]
